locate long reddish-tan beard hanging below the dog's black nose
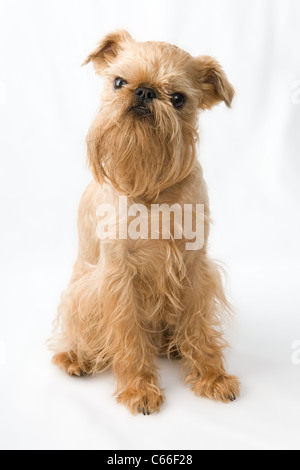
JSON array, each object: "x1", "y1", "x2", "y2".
[{"x1": 87, "y1": 102, "x2": 197, "y2": 200}]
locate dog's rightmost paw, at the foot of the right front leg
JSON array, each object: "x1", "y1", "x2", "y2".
[{"x1": 193, "y1": 374, "x2": 240, "y2": 403}]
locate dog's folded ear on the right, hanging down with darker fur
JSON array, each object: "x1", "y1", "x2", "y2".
[{"x1": 194, "y1": 56, "x2": 234, "y2": 109}]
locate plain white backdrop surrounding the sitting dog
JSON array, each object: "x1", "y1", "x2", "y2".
[{"x1": 0, "y1": 0, "x2": 300, "y2": 449}]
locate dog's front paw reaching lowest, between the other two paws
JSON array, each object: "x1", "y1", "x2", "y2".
[{"x1": 117, "y1": 385, "x2": 165, "y2": 415}]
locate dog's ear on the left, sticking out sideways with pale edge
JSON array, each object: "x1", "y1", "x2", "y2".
[{"x1": 82, "y1": 30, "x2": 133, "y2": 74}]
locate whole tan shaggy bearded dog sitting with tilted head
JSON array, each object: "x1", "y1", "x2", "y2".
[{"x1": 51, "y1": 31, "x2": 239, "y2": 415}]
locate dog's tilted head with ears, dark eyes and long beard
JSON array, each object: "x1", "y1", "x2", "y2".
[{"x1": 85, "y1": 31, "x2": 234, "y2": 200}]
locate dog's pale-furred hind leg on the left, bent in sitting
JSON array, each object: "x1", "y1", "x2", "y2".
[{"x1": 49, "y1": 265, "x2": 106, "y2": 375}]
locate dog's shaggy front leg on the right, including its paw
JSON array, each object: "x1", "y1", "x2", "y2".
[{"x1": 179, "y1": 253, "x2": 239, "y2": 402}]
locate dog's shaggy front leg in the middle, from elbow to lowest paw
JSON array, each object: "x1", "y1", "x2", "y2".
[{"x1": 102, "y1": 244, "x2": 164, "y2": 414}]
